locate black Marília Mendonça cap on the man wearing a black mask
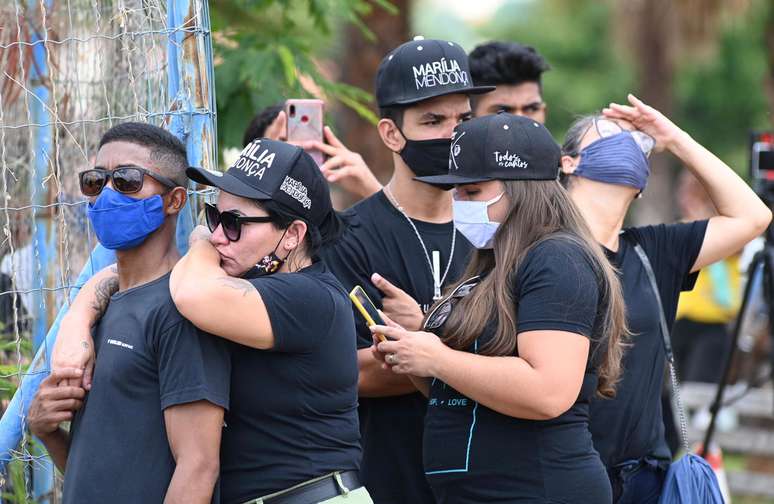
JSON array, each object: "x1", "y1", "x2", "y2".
[{"x1": 376, "y1": 36, "x2": 495, "y2": 107}]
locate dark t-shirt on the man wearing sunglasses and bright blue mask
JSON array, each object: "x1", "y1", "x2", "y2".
[{"x1": 64, "y1": 274, "x2": 230, "y2": 504}]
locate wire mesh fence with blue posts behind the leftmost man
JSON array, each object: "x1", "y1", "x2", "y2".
[{"x1": 0, "y1": 0, "x2": 215, "y2": 502}]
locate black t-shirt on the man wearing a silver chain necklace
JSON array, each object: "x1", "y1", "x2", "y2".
[{"x1": 322, "y1": 192, "x2": 472, "y2": 504}]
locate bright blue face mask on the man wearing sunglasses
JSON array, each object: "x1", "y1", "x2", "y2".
[{"x1": 88, "y1": 187, "x2": 165, "y2": 250}]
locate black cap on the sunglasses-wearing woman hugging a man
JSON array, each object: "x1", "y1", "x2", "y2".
[{"x1": 185, "y1": 138, "x2": 333, "y2": 227}]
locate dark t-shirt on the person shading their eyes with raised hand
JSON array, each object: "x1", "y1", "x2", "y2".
[{"x1": 591, "y1": 220, "x2": 707, "y2": 467}]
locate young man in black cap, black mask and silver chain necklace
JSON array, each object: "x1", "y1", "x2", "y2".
[{"x1": 323, "y1": 38, "x2": 493, "y2": 504}]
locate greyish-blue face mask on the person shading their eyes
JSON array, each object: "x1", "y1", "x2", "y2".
[{"x1": 573, "y1": 131, "x2": 650, "y2": 191}]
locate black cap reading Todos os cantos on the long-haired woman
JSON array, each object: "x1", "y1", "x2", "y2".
[{"x1": 416, "y1": 113, "x2": 562, "y2": 186}]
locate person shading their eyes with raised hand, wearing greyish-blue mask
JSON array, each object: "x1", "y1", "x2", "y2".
[{"x1": 562, "y1": 95, "x2": 771, "y2": 503}]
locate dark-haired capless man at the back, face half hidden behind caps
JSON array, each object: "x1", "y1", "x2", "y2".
[{"x1": 469, "y1": 42, "x2": 550, "y2": 124}]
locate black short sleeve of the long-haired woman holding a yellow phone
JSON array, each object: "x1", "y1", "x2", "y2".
[{"x1": 514, "y1": 237, "x2": 599, "y2": 337}]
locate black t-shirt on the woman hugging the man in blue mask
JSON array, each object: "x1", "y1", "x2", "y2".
[{"x1": 221, "y1": 262, "x2": 360, "y2": 504}]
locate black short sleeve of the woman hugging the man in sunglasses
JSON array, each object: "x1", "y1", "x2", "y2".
[{"x1": 250, "y1": 273, "x2": 334, "y2": 353}]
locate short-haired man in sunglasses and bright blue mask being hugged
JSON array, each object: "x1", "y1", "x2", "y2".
[{"x1": 37, "y1": 123, "x2": 230, "y2": 504}]
